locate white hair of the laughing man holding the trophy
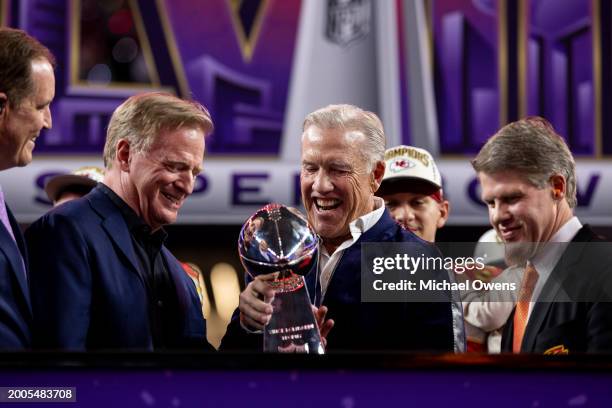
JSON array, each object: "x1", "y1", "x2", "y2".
[{"x1": 302, "y1": 105, "x2": 387, "y2": 170}]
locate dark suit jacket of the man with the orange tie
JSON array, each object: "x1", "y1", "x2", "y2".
[{"x1": 502, "y1": 225, "x2": 612, "y2": 354}]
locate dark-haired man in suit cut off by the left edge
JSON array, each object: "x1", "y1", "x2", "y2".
[{"x1": 0, "y1": 27, "x2": 55, "y2": 349}]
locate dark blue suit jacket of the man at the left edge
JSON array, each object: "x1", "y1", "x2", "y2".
[{"x1": 0, "y1": 206, "x2": 32, "y2": 350}]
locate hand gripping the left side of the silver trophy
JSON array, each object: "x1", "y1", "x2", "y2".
[{"x1": 238, "y1": 272, "x2": 278, "y2": 331}]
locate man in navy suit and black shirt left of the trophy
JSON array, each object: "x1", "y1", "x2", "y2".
[{"x1": 26, "y1": 93, "x2": 218, "y2": 350}]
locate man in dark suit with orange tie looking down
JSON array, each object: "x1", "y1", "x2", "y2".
[{"x1": 472, "y1": 117, "x2": 612, "y2": 354}]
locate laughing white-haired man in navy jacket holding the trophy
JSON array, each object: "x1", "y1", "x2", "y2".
[{"x1": 221, "y1": 105, "x2": 463, "y2": 352}]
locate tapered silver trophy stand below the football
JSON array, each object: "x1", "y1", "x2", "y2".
[{"x1": 264, "y1": 272, "x2": 325, "y2": 354}]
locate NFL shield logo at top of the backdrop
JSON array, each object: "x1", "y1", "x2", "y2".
[{"x1": 325, "y1": 0, "x2": 372, "y2": 46}]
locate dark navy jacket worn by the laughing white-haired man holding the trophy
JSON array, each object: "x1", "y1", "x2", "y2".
[{"x1": 221, "y1": 210, "x2": 455, "y2": 352}]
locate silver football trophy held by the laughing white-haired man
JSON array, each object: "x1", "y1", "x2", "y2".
[{"x1": 238, "y1": 204, "x2": 324, "y2": 354}]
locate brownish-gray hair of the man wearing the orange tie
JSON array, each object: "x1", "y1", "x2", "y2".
[{"x1": 471, "y1": 116, "x2": 577, "y2": 208}]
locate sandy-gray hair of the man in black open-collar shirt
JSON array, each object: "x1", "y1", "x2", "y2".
[{"x1": 104, "y1": 92, "x2": 213, "y2": 169}]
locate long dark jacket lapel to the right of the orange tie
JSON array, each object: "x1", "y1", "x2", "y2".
[{"x1": 512, "y1": 225, "x2": 593, "y2": 352}]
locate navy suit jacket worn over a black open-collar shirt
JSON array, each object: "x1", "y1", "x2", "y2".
[{"x1": 26, "y1": 188, "x2": 210, "y2": 350}]
